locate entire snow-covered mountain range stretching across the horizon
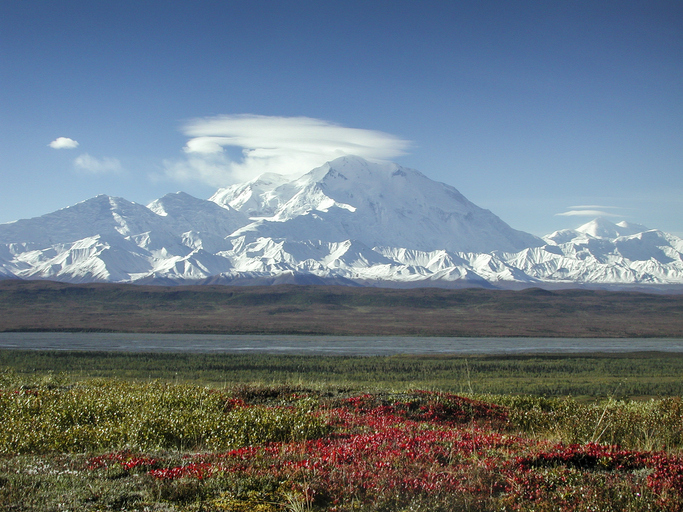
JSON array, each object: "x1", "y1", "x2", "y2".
[{"x1": 0, "y1": 157, "x2": 683, "y2": 288}]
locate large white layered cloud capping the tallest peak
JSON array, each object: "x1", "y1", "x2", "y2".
[{"x1": 164, "y1": 115, "x2": 411, "y2": 187}]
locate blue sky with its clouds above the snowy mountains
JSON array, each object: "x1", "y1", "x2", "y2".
[{"x1": 0, "y1": 0, "x2": 683, "y2": 236}]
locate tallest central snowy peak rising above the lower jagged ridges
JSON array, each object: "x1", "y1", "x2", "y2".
[{"x1": 211, "y1": 157, "x2": 543, "y2": 252}]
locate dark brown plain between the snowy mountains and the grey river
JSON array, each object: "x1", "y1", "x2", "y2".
[{"x1": 0, "y1": 281, "x2": 683, "y2": 338}]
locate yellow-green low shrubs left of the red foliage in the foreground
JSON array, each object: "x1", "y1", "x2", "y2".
[{"x1": 0, "y1": 372, "x2": 327, "y2": 454}]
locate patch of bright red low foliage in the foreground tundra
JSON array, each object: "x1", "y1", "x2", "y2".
[{"x1": 90, "y1": 392, "x2": 683, "y2": 511}]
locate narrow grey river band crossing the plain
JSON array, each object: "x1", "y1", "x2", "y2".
[{"x1": 0, "y1": 332, "x2": 683, "y2": 356}]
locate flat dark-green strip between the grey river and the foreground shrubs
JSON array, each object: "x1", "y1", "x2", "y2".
[{"x1": 0, "y1": 350, "x2": 683, "y2": 398}]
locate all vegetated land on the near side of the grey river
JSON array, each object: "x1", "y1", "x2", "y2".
[{"x1": 0, "y1": 350, "x2": 683, "y2": 512}]
